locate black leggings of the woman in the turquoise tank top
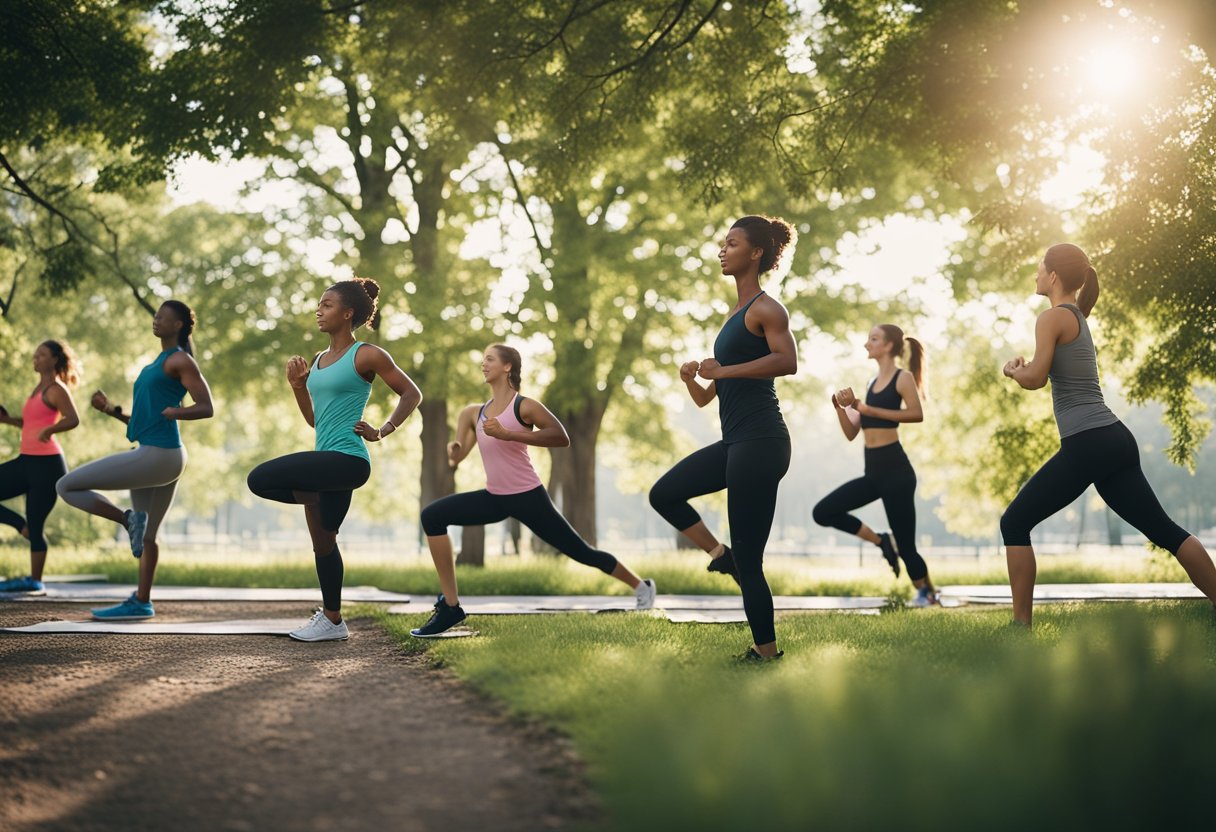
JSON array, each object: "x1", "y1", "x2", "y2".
[{"x1": 241, "y1": 451, "x2": 372, "y2": 612}]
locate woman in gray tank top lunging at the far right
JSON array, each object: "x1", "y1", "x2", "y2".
[{"x1": 1001, "y1": 243, "x2": 1216, "y2": 626}]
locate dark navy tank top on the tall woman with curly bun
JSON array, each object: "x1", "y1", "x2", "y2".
[{"x1": 714, "y1": 292, "x2": 789, "y2": 444}]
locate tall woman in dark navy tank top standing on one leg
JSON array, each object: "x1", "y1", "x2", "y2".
[{"x1": 651, "y1": 217, "x2": 798, "y2": 660}]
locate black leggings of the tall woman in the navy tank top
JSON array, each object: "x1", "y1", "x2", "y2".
[{"x1": 651, "y1": 439, "x2": 789, "y2": 645}]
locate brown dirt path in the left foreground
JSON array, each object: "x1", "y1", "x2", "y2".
[{"x1": 0, "y1": 603, "x2": 597, "y2": 832}]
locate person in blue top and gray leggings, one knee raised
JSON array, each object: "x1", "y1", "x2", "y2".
[{"x1": 57, "y1": 300, "x2": 214, "y2": 620}]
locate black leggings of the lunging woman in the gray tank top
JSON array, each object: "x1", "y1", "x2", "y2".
[{"x1": 1001, "y1": 422, "x2": 1190, "y2": 553}]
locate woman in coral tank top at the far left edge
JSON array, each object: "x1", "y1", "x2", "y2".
[{"x1": 0, "y1": 341, "x2": 80, "y2": 592}]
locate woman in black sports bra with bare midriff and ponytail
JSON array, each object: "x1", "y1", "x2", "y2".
[{"x1": 815, "y1": 324, "x2": 938, "y2": 607}]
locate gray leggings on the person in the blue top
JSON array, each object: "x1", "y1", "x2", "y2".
[{"x1": 55, "y1": 445, "x2": 186, "y2": 543}]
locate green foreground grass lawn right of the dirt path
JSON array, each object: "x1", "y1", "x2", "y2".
[{"x1": 379, "y1": 602, "x2": 1216, "y2": 831}]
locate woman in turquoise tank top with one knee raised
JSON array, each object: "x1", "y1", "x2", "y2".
[{"x1": 248, "y1": 277, "x2": 422, "y2": 641}]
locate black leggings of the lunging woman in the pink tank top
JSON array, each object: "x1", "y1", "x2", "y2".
[{"x1": 422, "y1": 485, "x2": 617, "y2": 575}]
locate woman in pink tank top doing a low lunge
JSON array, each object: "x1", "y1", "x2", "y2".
[{"x1": 411, "y1": 344, "x2": 654, "y2": 639}]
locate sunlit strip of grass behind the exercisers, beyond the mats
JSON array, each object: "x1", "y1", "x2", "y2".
[{"x1": 0, "y1": 546, "x2": 1187, "y2": 597}]
